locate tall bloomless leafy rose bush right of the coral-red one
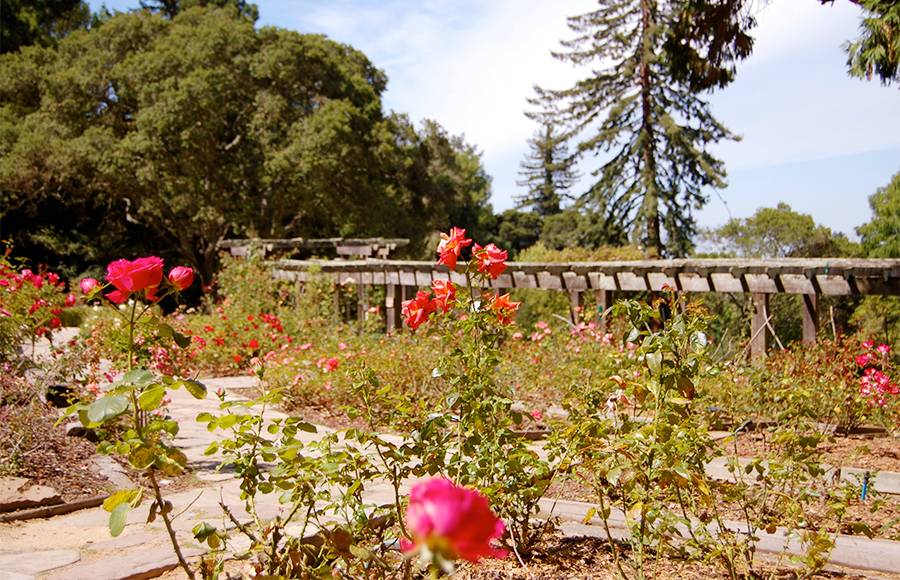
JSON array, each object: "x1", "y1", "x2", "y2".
[{"x1": 563, "y1": 292, "x2": 715, "y2": 578}]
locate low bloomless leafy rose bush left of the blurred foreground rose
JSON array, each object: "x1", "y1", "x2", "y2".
[{"x1": 194, "y1": 359, "x2": 410, "y2": 578}]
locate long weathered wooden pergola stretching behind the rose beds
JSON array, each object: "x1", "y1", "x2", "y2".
[{"x1": 273, "y1": 259, "x2": 900, "y2": 357}]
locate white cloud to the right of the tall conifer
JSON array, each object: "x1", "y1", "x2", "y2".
[{"x1": 712, "y1": 0, "x2": 900, "y2": 170}]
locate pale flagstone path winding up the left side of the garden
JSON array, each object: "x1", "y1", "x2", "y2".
[{"x1": 0, "y1": 377, "x2": 310, "y2": 580}]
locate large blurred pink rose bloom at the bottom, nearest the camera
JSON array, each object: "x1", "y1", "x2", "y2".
[{"x1": 401, "y1": 478, "x2": 507, "y2": 562}]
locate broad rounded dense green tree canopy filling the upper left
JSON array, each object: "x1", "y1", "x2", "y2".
[{"x1": 0, "y1": 6, "x2": 490, "y2": 276}]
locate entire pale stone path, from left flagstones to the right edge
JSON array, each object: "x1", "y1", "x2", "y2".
[{"x1": 0, "y1": 377, "x2": 900, "y2": 580}]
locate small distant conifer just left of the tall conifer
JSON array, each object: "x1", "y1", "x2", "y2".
[{"x1": 516, "y1": 122, "x2": 578, "y2": 217}]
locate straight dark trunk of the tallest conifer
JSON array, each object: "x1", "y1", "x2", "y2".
[{"x1": 640, "y1": 0, "x2": 663, "y2": 256}]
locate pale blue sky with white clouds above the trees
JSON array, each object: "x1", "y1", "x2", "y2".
[{"x1": 91, "y1": 0, "x2": 900, "y2": 235}]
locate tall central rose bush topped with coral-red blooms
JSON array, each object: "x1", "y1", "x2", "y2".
[{"x1": 403, "y1": 228, "x2": 559, "y2": 557}]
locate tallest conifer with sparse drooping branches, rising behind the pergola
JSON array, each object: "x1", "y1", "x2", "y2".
[{"x1": 532, "y1": 0, "x2": 734, "y2": 256}]
